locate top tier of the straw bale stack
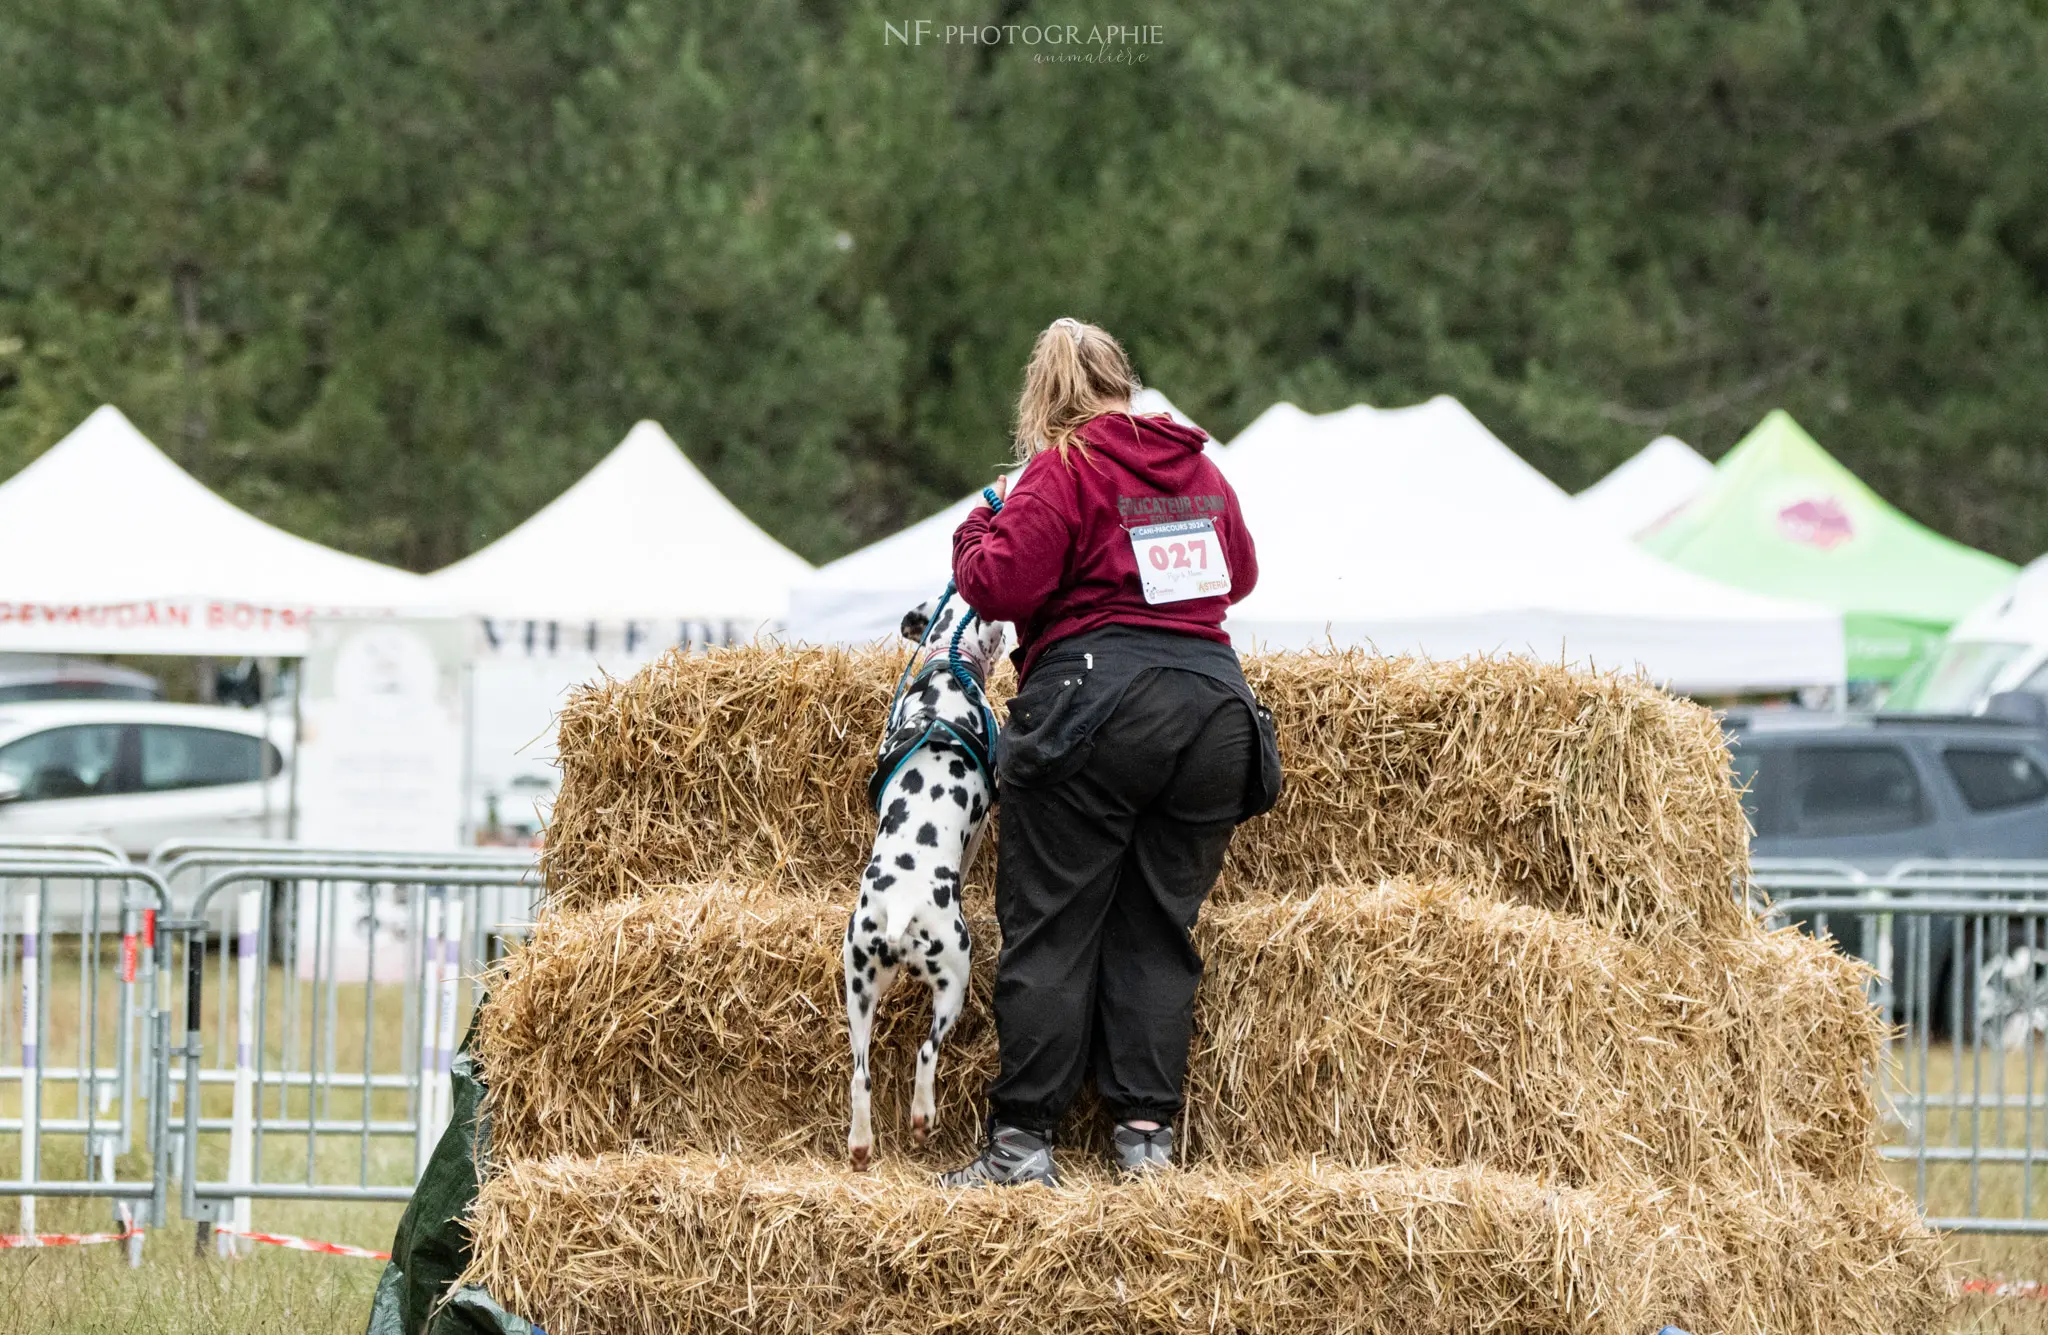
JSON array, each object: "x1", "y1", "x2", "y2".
[{"x1": 545, "y1": 645, "x2": 1747, "y2": 934}]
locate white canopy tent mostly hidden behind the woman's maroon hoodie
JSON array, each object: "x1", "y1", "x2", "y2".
[{"x1": 788, "y1": 389, "x2": 1194, "y2": 645}]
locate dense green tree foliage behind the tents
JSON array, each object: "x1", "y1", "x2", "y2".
[{"x1": 0, "y1": 0, "x2": 2048, "y2": 569}]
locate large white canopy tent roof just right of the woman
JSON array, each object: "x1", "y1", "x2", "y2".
[{"x1": 1221, "y1": 397, "x2": 1843, "y2": 692}]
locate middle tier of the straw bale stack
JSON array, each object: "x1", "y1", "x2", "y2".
[{"x1": 479, "y1": 885, "x2": 1880, "y2": 1183}]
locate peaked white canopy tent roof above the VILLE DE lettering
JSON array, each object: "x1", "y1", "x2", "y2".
[{"x1": 426, "y1": 422, "x2": 811, "y2": 639}]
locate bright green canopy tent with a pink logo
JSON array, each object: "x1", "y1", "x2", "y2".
[{"x1": 1640, "y1": 410, "x2": 2013, "y2": 682}]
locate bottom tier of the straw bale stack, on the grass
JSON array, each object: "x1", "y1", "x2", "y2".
[{"x1": 465, "y1": 1155, "x2": 1950, "y2": 1335}]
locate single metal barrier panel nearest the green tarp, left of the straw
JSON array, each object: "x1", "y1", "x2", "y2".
[{"x1": 174, "y1": 860, "x2": 532, "y2": 1231}]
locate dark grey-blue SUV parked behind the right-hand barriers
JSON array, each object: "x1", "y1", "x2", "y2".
[{"x1": 1726, "y1": 702, "x2": 2048, "y2": 1034}]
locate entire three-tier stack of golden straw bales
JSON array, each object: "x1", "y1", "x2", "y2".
[{"x1": 467, "y1": 649, "x2": 1948, "y2": 1335}]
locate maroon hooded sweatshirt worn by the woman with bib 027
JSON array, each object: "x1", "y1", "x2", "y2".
[{"x1": 952, "y1": 414, "x2": 1260, "y2": 678}]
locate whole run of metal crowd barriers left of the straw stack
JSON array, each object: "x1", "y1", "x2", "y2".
[{"x1": 0, "y1": 839, "x2": 539, "y2": 1261}]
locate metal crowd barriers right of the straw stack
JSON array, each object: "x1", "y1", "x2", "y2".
[{"x1": 1755, "y1": 860, "x2": 2048, "y2": 1233}]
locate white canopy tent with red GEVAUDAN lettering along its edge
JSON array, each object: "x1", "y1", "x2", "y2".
[{"x1": 0, "y1": 405, "x2": 424, "y2": 657}]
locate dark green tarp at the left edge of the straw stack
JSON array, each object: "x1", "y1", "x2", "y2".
[{"x1": 365, "y1": 1007, "x2": 541, "y2": 1335}]
